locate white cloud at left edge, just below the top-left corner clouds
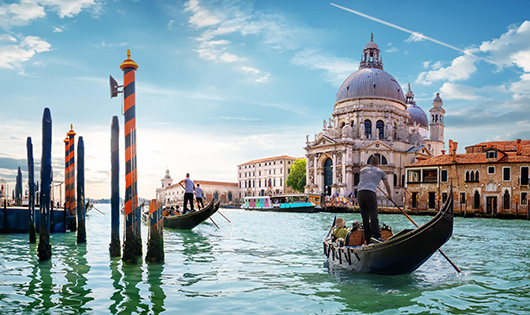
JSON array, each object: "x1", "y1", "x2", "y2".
[{"x1": 0, "y1": 36, "x2": 51, "y2": 73}]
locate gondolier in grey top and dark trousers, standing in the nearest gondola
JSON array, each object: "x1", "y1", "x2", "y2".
[{"x1": 357, "y1": 155, "x2": 392, "y2": 243}]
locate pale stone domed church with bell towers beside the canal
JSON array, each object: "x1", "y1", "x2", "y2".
[{"x1": 304, "y1": 36, "x2": 445, "y2": 203}]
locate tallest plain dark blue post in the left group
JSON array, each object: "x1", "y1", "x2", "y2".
[{"x1": 37, "y1": 108, "x2": 53, "y2": 260}]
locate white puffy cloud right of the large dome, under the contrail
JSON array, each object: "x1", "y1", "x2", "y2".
[{"x1": 416, "y1": 55, "x2": 477, "y2": 85}]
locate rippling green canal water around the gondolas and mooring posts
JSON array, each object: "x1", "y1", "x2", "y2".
[{"x1": 0, "y1": 205, "x2": 530, "y2": 315}]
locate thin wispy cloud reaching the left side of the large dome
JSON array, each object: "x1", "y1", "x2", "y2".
[{"x1": 291, "y1": 49, "x2": 357, "y2": 86}]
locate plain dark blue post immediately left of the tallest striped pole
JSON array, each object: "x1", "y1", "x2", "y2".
[{"x1": 109, "y1": 116, "x2": 121, "y2": 257}]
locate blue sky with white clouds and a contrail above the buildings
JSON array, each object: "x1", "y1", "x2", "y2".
[{"x1": 0, "y1": 0, "x2": 530, "y2": 198}]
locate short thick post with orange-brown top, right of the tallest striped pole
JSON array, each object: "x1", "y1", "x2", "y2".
[{"x1": 145, "y1": 199, "x2": 164, "y2": 263}]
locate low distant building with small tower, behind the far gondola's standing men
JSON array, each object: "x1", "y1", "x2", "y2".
[{"x1": 156, "y1": 170, "x2": 235, "y2": 205}]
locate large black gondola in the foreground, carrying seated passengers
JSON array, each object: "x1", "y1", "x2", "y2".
[{"x1": 324, "y1": 192, "x2": 453, "y2": 275}]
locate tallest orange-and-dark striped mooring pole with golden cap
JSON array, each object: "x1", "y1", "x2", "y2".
[{"x1": 120, "y1": 50, "x2": 142, "y2": 262}]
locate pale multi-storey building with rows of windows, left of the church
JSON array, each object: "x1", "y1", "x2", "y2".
[{"x1": 237, "y1": 155, "x2": 298, "y2": 199}]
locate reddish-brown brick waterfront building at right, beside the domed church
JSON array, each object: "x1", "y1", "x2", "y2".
[{"x1": 406, "y1": 139, "x2": 530, "y2": 215}]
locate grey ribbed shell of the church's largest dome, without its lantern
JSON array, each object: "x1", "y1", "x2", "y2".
[{"x1": 337, "y1": 68, "x2": 405, "y2": 103}]
